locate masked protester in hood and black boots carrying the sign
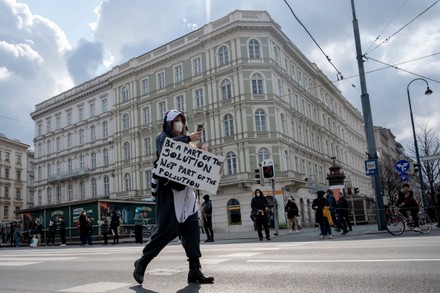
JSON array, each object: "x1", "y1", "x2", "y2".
[{"x1": 133, "y1": 110, "x2": 214, "y2": 284}]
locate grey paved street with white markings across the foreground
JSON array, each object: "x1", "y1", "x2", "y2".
[{"x1": 0, "y1": 226, "x2": 440, "y2": 293}]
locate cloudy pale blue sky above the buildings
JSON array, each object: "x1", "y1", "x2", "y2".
[{"x1": 0, "y1": 0, "x2": 440, "y2": 150}]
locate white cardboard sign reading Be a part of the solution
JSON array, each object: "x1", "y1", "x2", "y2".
[{"x1": 156, "y1": 137, "x2": 224, "y2": 194}]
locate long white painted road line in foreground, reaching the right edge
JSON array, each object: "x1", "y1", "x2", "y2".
[{"x1": 247, "y1": 258, "x2": 440, "y2": 263}]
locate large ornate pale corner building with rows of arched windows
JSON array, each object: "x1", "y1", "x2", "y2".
[{"x1": 31, "y1": 11, "x2": 373, "y2": 231}]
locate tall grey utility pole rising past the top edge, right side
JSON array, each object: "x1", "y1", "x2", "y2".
[{"x1": 351, "y1": 0, "x2": 386, "y2": 230}]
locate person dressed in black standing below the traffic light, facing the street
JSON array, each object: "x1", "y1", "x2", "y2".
[{"x1": 251, "y1": 189, "x2": 270, "y2": 241}]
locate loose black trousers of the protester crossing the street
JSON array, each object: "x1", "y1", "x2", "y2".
[{"x1": 142, "y1": 194, "x2": 202, "y2": 260}]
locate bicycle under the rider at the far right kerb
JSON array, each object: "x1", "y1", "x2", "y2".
[{"x1": 387, "y1": 206, "x2": 432, "y2": 236}]
